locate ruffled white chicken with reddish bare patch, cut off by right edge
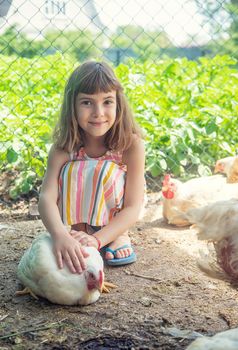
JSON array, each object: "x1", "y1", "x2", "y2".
[{"x1": 185, "y1": 199, "x2": 238, "y2": 282}]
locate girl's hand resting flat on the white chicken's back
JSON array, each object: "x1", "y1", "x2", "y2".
[{"x1": 54, "y1": 233, "x2": 89, "y2": 274}]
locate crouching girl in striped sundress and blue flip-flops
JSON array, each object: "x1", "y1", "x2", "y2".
[{"x1": 39, "y1": 62, "x2": 145, "y2": 273}]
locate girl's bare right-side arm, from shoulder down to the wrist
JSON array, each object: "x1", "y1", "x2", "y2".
[{"x1": 94, "y1": 136, "x2": 145, "y2": 247}]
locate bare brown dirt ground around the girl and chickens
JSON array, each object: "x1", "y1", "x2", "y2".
[{"x1": 0, "y1": 193, "x2": 238, "y2": 350}]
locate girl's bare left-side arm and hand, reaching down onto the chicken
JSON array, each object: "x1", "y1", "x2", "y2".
[{"x1": 39, "y1": 146, "x2": 88, "y2": 273}]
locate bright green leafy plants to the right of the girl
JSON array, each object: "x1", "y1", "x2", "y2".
[{"x1": 117, "y1": 56, "x2": 238, "y2": 177}]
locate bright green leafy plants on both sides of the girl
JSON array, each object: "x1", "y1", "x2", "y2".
[{"x1": 0, "y1": 54, "x2": 238, "y2": 198}]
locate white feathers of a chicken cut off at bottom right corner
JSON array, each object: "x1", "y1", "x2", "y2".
[{"x1": 186, "y1": 328, "x2": 238, "y2": 350}]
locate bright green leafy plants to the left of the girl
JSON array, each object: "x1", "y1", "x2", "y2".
[{"x1": 0, "y1": 54, "x2": 76, "y2": 198}]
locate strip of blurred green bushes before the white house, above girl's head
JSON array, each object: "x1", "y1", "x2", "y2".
[{"x1": 0, "y1": 25, "x2": 172, "y2": 62}]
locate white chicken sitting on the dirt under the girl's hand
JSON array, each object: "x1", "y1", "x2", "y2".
[{"x1": 17, "y1": 233, "x2": 104, "y2": 305}]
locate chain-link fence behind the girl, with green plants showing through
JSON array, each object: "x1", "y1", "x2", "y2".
[{"x1": 0, "y1": 0, "x2": 238, "y2": 213}]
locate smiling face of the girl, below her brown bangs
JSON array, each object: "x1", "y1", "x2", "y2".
[{"x1": 76, "y1": 90, "x2": 117, "y2": 139}]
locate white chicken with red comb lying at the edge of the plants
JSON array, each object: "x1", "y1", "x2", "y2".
[{"x1": 162, "y1": 174, "x2": 229, "y2": 226}]
